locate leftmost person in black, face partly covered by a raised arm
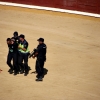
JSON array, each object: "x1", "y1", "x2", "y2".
[{"x1": 7, "y1": 38, "x2": 19, "y2": 74}]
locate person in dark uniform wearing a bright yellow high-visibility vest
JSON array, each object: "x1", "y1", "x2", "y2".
[{"x1": 18, "y1": 34, "x2": 29, "y2": 75}]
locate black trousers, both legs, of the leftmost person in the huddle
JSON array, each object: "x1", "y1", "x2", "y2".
[{"x1": 7, "y1": 52, "x2": 19, "y2": 71}]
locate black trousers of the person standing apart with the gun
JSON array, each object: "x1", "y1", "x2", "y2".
[{"x1": 35, "y1": 59, "x2": 44, "y2": 77}]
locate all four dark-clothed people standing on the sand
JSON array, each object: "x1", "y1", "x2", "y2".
[{"x1": 6, "y1": 31, "x2": 47, "y2": 81}]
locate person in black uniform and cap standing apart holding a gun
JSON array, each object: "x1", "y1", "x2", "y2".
[{"x1": 33, "y1": 38, "x2": 47, "y2": 81}]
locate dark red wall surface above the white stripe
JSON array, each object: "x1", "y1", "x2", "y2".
[{"x1": 1, "y1": 0, "x2": 100, "y2": 14}]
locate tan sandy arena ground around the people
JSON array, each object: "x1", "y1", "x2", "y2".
[{"x1": 0, "y1": 7, "x2": 100, "y2": 100}]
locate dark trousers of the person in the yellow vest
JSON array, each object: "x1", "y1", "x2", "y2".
[{"x1": 18, "y1": 52, "x2": 28, "y2": 72}]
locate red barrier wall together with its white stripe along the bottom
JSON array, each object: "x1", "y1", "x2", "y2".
[{"x1": 0, "y1": 0, "x2": 100, "y2": 17}]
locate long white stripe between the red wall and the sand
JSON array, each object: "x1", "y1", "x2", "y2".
[{"x1": 0, "y1": 2, "x2": 100, "y2": 18}]
